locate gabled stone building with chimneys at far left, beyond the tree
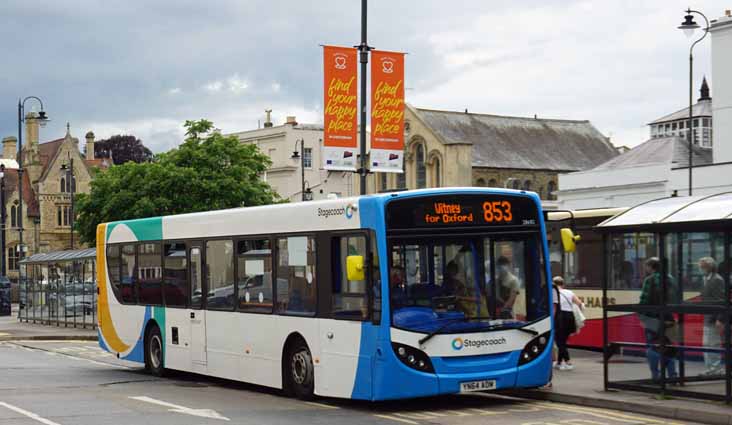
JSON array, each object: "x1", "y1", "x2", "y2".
[{"x1": 2, "y1": 112, "x2": 110, "y2": 280}]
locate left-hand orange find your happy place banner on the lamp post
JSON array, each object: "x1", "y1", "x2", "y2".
[{"x1": 323, "y1": 46, "x2": 358, "y2": 171}]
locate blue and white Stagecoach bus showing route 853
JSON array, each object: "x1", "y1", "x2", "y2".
[{"x1": 97, "y1": 188, "x2": 553, "y2": 400}]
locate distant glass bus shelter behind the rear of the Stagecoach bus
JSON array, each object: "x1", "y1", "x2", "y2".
[{"x1": 18, "y1": 248, "x2": 97, "y2": 329}]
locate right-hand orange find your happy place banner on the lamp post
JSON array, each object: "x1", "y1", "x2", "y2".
[{"x1": 371, "y1": 50, "x2": 404, "y2": 173}]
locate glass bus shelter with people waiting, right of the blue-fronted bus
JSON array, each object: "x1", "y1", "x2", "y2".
[{"x1": 597, "y1": 193, "x2": 732, "y2": 403}]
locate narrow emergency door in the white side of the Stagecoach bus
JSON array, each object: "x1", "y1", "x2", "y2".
[{"x1": 188, "y1": 242, "x2": 206, "y2": 366}]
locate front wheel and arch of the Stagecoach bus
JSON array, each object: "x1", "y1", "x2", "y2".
[{"x1": 282, "y1": 332, "x2": 315, "y2": 400}]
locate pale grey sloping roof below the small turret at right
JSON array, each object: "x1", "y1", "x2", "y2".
[{"x1": 593, "y1": 136, "x2": 712, "y2": 171}]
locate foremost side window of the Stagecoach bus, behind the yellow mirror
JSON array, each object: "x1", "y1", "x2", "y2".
[{"x1": 331, "y1": 236, "x2": 368, "y2": 320}]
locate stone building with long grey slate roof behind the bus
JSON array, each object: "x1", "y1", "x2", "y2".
[{"x1": 356, "y1": 105, "x2": 618, "y2": 200}]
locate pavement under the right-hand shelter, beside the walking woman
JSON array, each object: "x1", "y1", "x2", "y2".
[{"x1": 510, "y1": 350, "x2": 732, "y2": 425}]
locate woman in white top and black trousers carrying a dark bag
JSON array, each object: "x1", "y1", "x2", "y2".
[{"x1": 552, "y1": 276, "x2": 582, "y2": 370}]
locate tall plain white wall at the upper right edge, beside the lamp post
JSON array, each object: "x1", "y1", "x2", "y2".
[{"x1": 712, "y1": 16, "x2": 732, "y2": 164}]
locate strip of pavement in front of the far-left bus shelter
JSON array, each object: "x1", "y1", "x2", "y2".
[{"x1": 0, "y1": 304, "x2": 97, "y2": 341}]
